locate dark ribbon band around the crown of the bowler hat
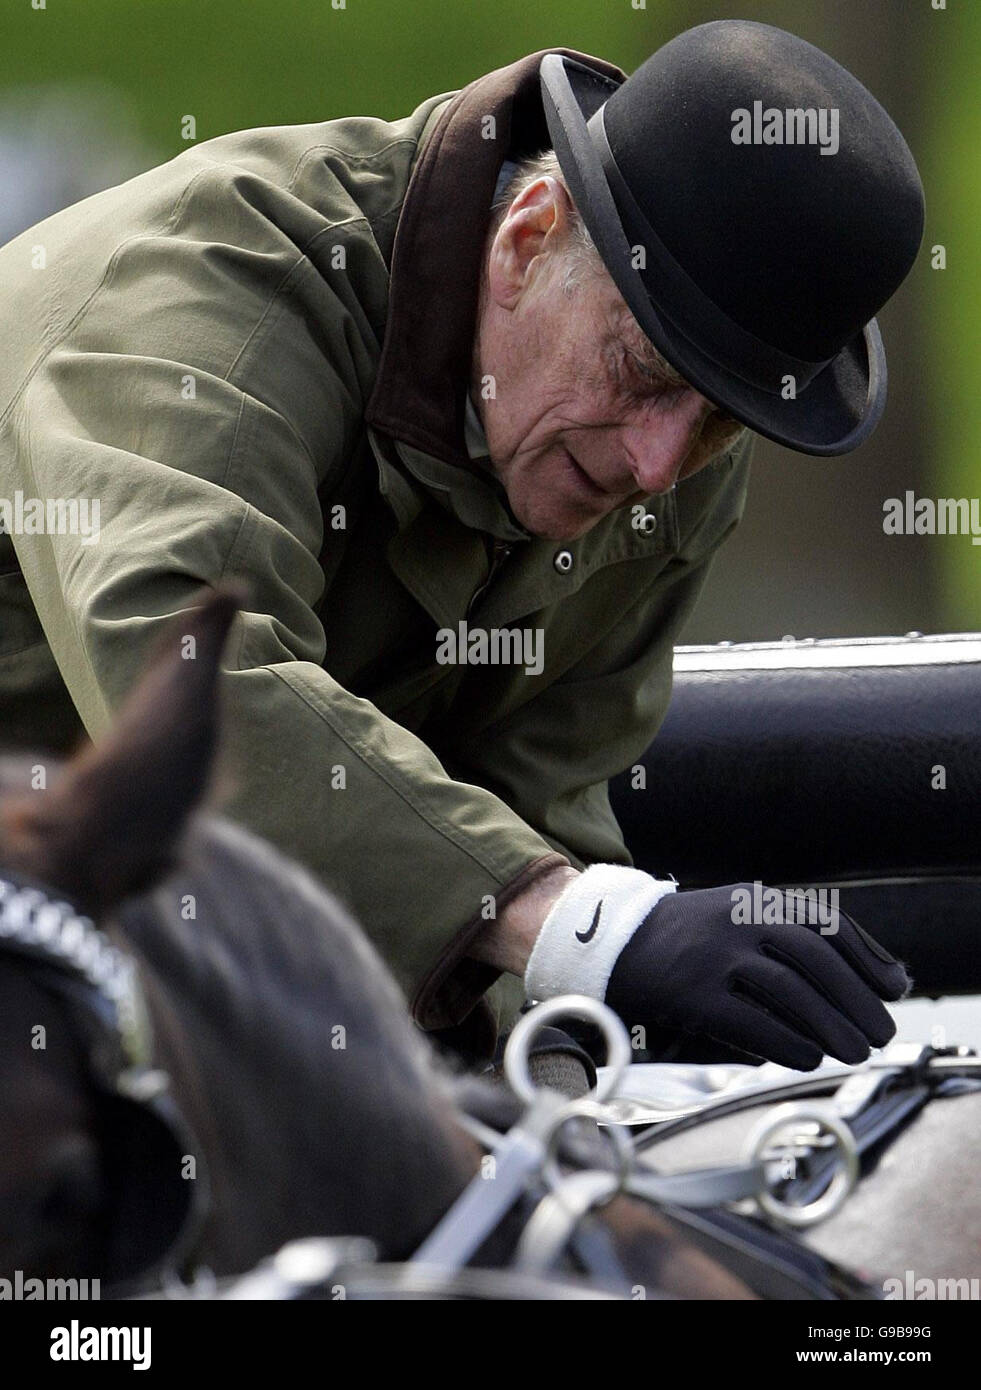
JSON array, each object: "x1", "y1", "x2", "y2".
[{"x1": 586, "y1": 107, "x2": 836, "y2": 395}]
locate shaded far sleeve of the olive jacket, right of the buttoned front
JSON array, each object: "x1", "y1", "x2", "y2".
[{"x1": 422, "y1": 434, "x2": 755, "y2": 1022}]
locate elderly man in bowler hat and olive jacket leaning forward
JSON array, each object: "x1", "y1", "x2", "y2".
[{"x1": 0, "y1": 21, "x2": 923, "y2": 1068}]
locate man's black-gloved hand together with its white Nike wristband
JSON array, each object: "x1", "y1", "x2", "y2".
[{"x1": 525, "y1": 865, "x2": 910, "y2": 1070}]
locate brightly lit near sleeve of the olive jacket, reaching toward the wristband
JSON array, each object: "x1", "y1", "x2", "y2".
[{"x1": 0, "y1": 154, "x2": 561, "y2": 1023}]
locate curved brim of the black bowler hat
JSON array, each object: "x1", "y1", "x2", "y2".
[{"x1": 541, "y1": 53, "x2": 887, "y2": 457}]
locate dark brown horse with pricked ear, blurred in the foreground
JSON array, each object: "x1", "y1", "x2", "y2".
[{"x1": 0, "y1": 591, "x2": 752, "y2": 1298}]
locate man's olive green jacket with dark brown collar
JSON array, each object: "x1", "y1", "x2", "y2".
[{"x1": 0, "y1": 54, "x2": 749, "y2": 1047}]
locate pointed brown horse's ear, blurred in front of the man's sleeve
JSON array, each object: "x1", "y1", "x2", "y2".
[{"x1": 0, "y1": 584, "x2": 247, "y2": 915}]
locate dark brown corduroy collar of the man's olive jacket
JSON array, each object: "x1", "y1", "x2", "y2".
[{"x1": 365, "y1": 49, "x2": 625, "y2": 468}]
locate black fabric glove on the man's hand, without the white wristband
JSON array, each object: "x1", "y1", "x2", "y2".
[{"x1": 606, "y1": 884, "x2": 910, "y2": 1072}]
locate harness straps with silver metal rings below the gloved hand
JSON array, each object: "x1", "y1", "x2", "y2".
[{"x1": 191, "y1": 995, "x2": 981, "y2": 1300}]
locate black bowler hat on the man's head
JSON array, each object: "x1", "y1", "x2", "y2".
[{"x1": 541, "y1": 19, "x2": 924, "y2": 455}]
